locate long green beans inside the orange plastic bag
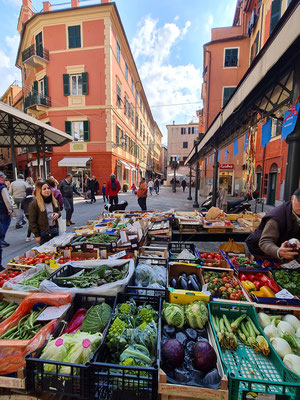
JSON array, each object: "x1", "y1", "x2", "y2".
[{"x1": 0, "y1": 307, "x2": 46, "y2": 340}]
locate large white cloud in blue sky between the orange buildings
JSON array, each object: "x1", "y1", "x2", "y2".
[{"x1": 131, "y1": 16, "x2": 202, "y2": 143}]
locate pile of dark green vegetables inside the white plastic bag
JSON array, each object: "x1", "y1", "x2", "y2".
[{"x1": 55, "y1": 263, "x2": 129, "y2": 288}]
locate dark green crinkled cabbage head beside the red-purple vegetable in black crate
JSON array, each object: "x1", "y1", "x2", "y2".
[{"x1": 80, "y1": 303, "x2": 112, "y2": 333}]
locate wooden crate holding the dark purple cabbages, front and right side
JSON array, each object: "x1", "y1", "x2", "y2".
[{"x1": 158, "y1": 323, "x2": 228, "y2": 400}]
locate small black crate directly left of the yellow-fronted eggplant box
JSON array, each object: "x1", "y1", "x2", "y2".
[{"x1": 126, "y1": 257, "x2": 169, "y2": 297}]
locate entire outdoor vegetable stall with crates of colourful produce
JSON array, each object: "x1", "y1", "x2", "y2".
[{"x1": 0, "y1": 210, "x2": 300, "y2": 400}]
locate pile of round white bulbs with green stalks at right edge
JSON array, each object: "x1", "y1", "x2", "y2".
[{"x1": 258, "y1": 312, "x2": 300, "y2": 375}]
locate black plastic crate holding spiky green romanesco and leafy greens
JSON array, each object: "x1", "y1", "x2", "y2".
[{"x1": 90, "y1": 293, "x2": 162, "y2": 400}]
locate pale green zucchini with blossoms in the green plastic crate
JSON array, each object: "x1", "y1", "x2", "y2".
[{"x1": 212, "y1": 314, "x2": 270, "y2": 356}]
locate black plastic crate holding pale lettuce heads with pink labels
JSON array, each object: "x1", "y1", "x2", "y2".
[{"x1": 26, "y1": 294, "x2": 116, "y2": 399}]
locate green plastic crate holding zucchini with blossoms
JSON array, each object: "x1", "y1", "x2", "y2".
[{"x1": 208, "y1": 302, "x2": 300, "y2": 400}]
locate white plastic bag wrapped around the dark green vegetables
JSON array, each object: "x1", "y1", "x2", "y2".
[{"x1": 40, "y1": 259, "x2": 134, "y2": 296}]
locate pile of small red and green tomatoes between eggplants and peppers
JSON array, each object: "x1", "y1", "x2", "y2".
[{"x1": 204, "y1": 271, "x2": 245, "y2": 301}]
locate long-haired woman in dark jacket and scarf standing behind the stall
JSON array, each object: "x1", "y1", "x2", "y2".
[{"x1": 28, "y1": 182, "x2": 60, "y2": 245}]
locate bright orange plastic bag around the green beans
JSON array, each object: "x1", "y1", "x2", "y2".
[{"x1": 0, "y1": 293, "x2": 72, "y2": 375}]
